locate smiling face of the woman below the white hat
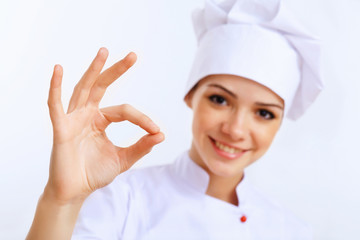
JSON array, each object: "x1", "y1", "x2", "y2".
[{"x1": 185, "y1": 75, "x2": 284, "y2": 181}]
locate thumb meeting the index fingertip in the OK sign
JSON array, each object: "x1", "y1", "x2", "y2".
[{"x1": 118, "y1": 132, "x2": 165, "y2": 172}]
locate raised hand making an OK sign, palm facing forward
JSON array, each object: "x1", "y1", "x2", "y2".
[{"x1": 44, "y1": 48, "x2": 164, "y2": 204}]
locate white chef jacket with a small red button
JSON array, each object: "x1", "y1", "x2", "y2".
[{"x1": 72, "y1": 152, "x2": 312, "y2": 240}]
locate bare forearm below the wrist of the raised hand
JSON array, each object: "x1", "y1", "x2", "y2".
[{"x1": 26, "y1": 195, "x2": 83, "y2": 240}]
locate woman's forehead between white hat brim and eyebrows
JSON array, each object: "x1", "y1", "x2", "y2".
[{"x1": 198, "y1": 74, "x2": 283, "y2": 103}]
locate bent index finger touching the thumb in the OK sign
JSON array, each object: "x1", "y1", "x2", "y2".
[{"x1": 101, "y1": 104, "x2": 160, "y2": 134}]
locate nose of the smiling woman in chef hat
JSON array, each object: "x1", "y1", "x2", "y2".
[{"x1": 221, "y1": 111, "x2": 250, "y2": 141}]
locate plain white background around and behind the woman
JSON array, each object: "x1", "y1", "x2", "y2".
[{"x1": 0, "y1": 0, "x2": 360, "y2": 240}]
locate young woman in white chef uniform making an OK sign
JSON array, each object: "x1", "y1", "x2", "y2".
[{"x1": 27, "y1": 0, "x2": 322, "y2": 240}]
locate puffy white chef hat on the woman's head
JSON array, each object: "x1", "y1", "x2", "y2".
[{"x1": 185, "y1": 0, "x2": 323, "y2": 120}]
